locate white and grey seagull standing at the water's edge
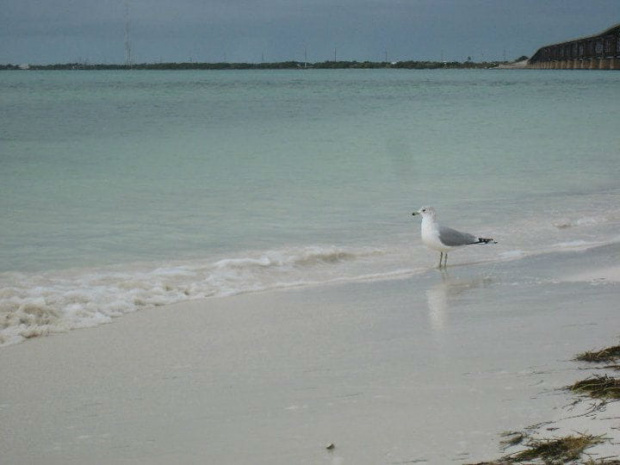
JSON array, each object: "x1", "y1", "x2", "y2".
[{"x1": 413, "y1": 207, "x2": 497, "y2": 268}]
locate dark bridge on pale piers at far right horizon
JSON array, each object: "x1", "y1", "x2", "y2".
[{"x1": 527, "y1": 24, "x2": 620, "y2": 69}]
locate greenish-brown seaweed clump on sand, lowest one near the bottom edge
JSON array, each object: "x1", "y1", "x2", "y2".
[{"x1": 468, "y1": 434, "x2": 610, "y2": 465}]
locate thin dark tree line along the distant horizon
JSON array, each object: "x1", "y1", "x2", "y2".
[{"x1": 0, "y1": 60, "x2": 505, "y2": 71}]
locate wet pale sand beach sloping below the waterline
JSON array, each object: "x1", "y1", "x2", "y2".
[{"x1": 0, "y1": 246, "x2": 620, "y2": 465}]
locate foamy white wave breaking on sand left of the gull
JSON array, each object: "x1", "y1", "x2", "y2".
[{"x1": 0, "y1": 246, "x2": 384, "y2": 346}]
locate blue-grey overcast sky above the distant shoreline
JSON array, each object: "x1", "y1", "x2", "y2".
[{"x1": 0, "y1": 0, "x2": 620, "y2": 64}]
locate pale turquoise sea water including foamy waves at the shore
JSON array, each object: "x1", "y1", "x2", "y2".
[{"x1": 0, "y1": 70, "x2": 620, "y2": 345}]
